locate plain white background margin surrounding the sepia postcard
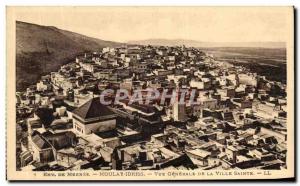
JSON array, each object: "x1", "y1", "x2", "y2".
[{"x1": 0, "y1": 0, "x2": 300, "y2": 185}]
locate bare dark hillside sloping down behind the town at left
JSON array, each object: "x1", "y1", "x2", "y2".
[{"x1": 16, "y1": 21, "x2": 121, "y2": 91}]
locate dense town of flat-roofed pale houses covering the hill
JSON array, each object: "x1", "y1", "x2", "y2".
[{"x1": 16, "y1": 45, "x2": 287, "y2": 171}]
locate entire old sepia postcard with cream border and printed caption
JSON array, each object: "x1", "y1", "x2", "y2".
[{"x1": 6, "y1": 6, "x2": 295, "y2": 181}]
